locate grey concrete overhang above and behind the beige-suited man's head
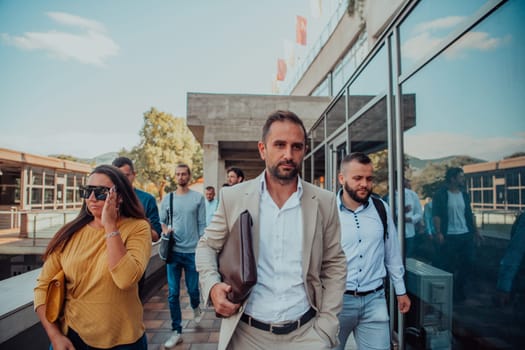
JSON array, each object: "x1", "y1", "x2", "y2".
[{"x1": 186, "y1": 93, "x2": 331, "y2": 178}]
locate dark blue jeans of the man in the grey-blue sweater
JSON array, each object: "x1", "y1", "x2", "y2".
[{"x1": 166, "y1": 252, "x2": 200, "y2": 333}]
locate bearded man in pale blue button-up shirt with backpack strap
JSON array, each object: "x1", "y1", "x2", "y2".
[{"x1": 336, "y1": 152, "x2": 410, "y2": 350}]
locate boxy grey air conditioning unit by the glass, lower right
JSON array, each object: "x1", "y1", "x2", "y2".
[{"x1": 406, "y1": 258, "x2": 453, "y2": 350}]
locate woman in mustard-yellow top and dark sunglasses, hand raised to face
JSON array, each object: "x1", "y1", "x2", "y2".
[{"x1": 34, "y1": 165, "x2": 151, "y2": 350}]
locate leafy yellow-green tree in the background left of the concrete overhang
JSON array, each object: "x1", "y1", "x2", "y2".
[{"x1": 130, "y1": 107, "x2": 203, "y2": 199}]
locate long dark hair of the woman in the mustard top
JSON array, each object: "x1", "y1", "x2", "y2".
[{"x1": 42, "y1": 165, "x2": 146, "y2": 260}]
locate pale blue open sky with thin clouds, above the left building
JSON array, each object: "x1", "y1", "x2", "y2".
[{"x1": 0, "y1": 0, "x2": 334, "y2": 157}]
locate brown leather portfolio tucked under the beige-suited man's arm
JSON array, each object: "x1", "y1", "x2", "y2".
[{"x1": 219, "y1": 210, "x2": 257, "y2": 304}]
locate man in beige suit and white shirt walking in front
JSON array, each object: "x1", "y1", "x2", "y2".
[{"x1": 196, "y1": 111, "x2": 346, "y2": 350}]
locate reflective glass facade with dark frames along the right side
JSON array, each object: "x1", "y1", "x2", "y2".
[{"x1": 306, "y1": 0, "x2": 525, "y2": 349}]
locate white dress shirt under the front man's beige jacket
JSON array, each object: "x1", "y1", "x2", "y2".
[{"x1": 245, "y1": 176, "x2": 310, "y2": 323}]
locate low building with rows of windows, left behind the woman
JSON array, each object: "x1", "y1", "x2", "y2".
[{"x1": 0, "y1": 148, "x2": 92, "y2": 237}]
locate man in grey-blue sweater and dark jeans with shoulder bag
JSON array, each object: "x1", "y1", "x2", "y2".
[{"x1": 160, "y1": 164, "x2": 206, "y2": 348}]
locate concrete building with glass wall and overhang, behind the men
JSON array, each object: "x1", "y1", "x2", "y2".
[{"x1": 187, "y1": 0, "x2": 525, "y2": 349}]
